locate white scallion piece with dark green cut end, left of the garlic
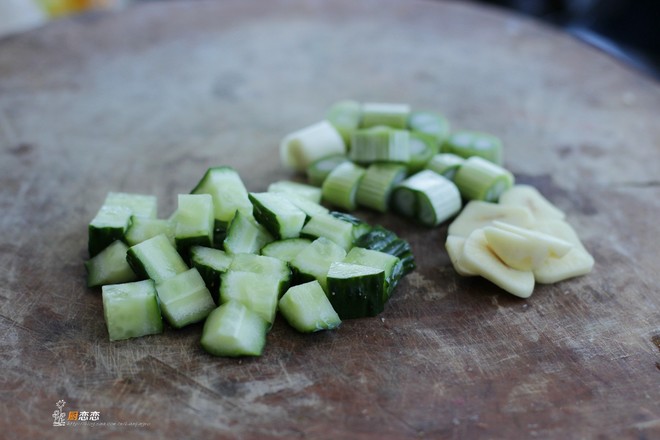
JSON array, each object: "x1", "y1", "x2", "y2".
[{"x1": 393, "y1": 170, "x2": 461, "y2": 226}]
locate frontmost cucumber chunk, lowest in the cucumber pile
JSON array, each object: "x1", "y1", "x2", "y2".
[{"x1": 200, "y1": 301, "x2": 268, "y2": 357}]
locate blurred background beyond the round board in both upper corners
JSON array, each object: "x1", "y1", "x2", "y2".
[{"x1": 0, "y1": 0, "x2": 660, "y2": 80}]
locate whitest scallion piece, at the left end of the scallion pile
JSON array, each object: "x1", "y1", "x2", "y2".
[{"x1": 280, "y1": 120, "x2": 346, "y2": 171}]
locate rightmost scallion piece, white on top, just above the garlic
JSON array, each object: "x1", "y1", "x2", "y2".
[{"x1": 454, "y1": 156, "x2": 514, "y2": 202}]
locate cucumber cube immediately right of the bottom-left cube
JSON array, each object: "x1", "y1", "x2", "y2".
[{"x1": 156, "y1": 268, "x2": 215, "y2": 328}]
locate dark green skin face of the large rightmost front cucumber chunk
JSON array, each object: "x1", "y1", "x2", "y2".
[{"x1": 327, "y1": 271, "x2": 387, "y2": 320}]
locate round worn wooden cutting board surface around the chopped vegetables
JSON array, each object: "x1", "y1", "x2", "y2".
[{"x1": 0, "y1": 0, "x2": 660, "y2": 439}]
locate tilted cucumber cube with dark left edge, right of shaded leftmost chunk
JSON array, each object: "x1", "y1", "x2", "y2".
[{"x1": 126, "y1": 234, "x2": 188, "y2": 283}]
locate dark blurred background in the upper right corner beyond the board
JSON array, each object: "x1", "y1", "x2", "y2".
[{"x1": 474, "y1": 0, "x2": 660, "y2": 80}]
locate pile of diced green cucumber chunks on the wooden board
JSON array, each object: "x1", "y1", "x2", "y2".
[{"x1": 85, "y1": 166, "x2": 415, "y2": 356}]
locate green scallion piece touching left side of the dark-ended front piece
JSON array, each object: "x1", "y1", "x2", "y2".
[{"x1": 356, "y1": 163, "x2": 406, "y2": 212}]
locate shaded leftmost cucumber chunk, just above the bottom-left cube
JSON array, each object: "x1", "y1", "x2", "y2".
[{"x1": 85, "y1": 240, "x2": 137, "y2": 287}]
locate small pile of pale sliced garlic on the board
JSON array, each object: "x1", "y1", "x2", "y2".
[{"x1": 445, "y1": 185, "x2": 594, "y2": 298}]
